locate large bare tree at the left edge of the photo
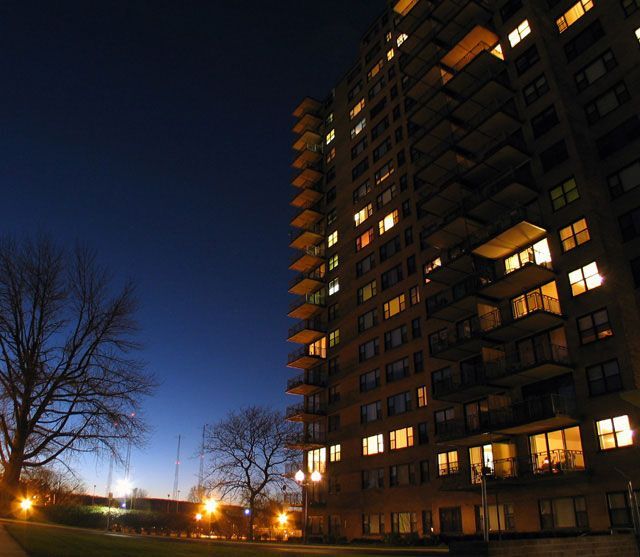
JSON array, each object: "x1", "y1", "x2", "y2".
[{"x1": 0, "y1": 237, "x2": 154, "y2": 512}]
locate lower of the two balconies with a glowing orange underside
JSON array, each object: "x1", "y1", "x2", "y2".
[{"x1": 471, "y1": 207, "x2": 547, "y2": 259}]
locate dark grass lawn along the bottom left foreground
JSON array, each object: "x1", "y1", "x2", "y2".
[{"x1": 5, "y1": 524, "x2": 404, "y2": 557}]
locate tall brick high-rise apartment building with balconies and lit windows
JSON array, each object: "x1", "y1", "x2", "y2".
[{"x1": 287, "y1": 0, "x2": 640, "y2": 539}]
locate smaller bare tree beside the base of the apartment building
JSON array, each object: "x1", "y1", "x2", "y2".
[{"x1": 204, "y1": 406, "x2": 297, "y2": 539}]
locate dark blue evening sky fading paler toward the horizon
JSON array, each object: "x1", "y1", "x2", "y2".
[{"x1": 0, "y1": 0, "x2": 385, "y2": 496}]
